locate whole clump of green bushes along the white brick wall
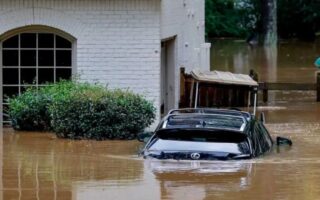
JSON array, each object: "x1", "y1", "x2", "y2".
[{"x1": 9, "y1": 81, "x2": 155, "y2": 140}]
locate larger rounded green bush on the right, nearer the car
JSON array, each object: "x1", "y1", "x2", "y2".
[{"x1": 50, "y1": 88, "x2": 155, "y2": 140}]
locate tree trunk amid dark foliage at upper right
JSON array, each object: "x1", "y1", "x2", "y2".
[{"x1": 262, "y1": 0, "x2": 278, "y2": 46}]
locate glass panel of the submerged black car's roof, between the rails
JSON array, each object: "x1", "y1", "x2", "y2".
[{"x1": 162, "y1": 114, "x2": 245, "y2": 130}]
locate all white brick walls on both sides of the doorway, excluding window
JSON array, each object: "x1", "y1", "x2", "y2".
[{"x1": 0, "y1": 0, "x2": 208, "y2": 128}]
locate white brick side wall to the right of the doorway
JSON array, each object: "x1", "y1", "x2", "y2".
[{"x1": 161, "y1": 0, "x2": 210, "y2": 107}]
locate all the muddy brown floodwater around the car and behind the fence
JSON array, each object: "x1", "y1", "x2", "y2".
[{"x1": 0, "y1": 41, "x2": 320, "y2": 200}]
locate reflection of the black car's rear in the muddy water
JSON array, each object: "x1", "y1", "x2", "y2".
[{"x1": 151, "y1": 160, "x2": 253, "y2": 199}]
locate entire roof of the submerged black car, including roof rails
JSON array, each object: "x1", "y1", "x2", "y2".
[{"x1": 159, "y1": 108, "x2": 251, "y2": 132}]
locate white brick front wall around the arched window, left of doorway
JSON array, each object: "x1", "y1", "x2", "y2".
[{"x1": 0, "y1": 0, "x2": 161, "y2": 126}]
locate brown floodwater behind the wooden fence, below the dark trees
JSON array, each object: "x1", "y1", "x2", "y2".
[{"x1": 211, "y1": 39, "x2": 320, "y2": 82}]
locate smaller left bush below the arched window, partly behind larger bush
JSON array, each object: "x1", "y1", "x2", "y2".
[{"x1": 9, "y1": 81, "x2": 81, "y2": 131}]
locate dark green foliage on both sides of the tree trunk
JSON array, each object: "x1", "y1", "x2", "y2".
[{"x1": 206, "y1": 0, "x2": 320, "y2": 40}]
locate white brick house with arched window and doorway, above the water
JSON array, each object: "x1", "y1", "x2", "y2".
[{"x1": 0, "y1": 0, "x2": 210, "y2": 125}]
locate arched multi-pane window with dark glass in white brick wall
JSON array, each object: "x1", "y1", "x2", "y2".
[{"x1": 0, "y1": 32, "x2": 72, "y2": 122}]
